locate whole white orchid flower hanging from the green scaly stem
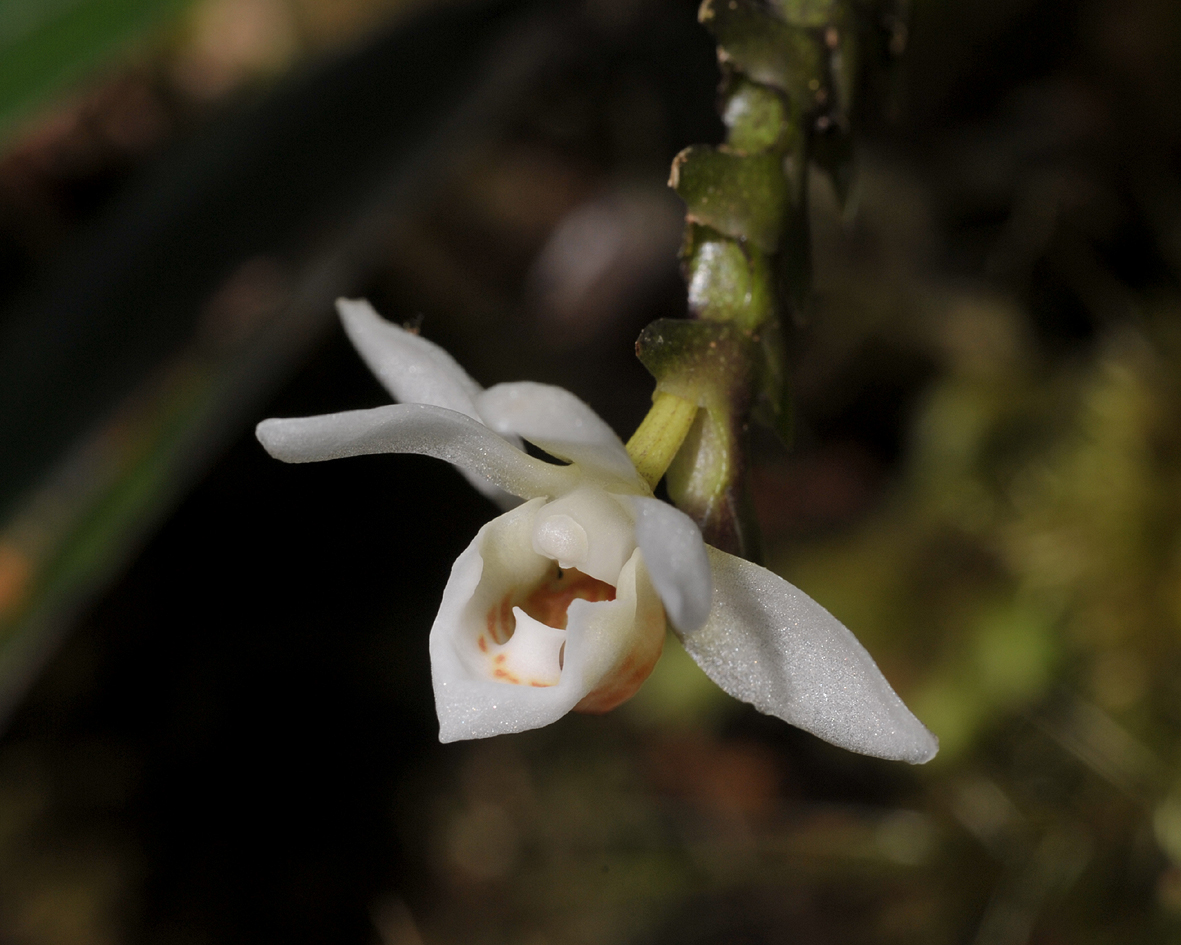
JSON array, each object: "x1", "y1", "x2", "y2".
[{"x1": 257, "y1": 300, "x2": 938, "y2": 763}]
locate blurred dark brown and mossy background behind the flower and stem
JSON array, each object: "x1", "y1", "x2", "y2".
[{"x1": 0, "y1": 0, "x2": 1181, "y2": 945}]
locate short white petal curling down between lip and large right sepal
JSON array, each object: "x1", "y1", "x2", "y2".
[{"x1": 629, "y1": 496, "x2": 713, "y2": 633}]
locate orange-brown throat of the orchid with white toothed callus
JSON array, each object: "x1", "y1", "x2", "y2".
[{"x1": 476, "y1": 565, "x2": 615, "y2": 686}]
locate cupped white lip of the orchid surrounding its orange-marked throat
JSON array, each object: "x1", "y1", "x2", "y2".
[{"x1": 430, "y1": 500, "x2": 663, "y2": 742}]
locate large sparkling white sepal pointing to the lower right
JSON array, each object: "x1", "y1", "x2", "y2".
[{"x1": 680, "y1": 546, "x2": 939, "y2": 764}]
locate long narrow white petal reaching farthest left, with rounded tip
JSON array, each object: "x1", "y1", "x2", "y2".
[{"x1": 255, "y1": 404, "x2": 579, "y2": 498}]
